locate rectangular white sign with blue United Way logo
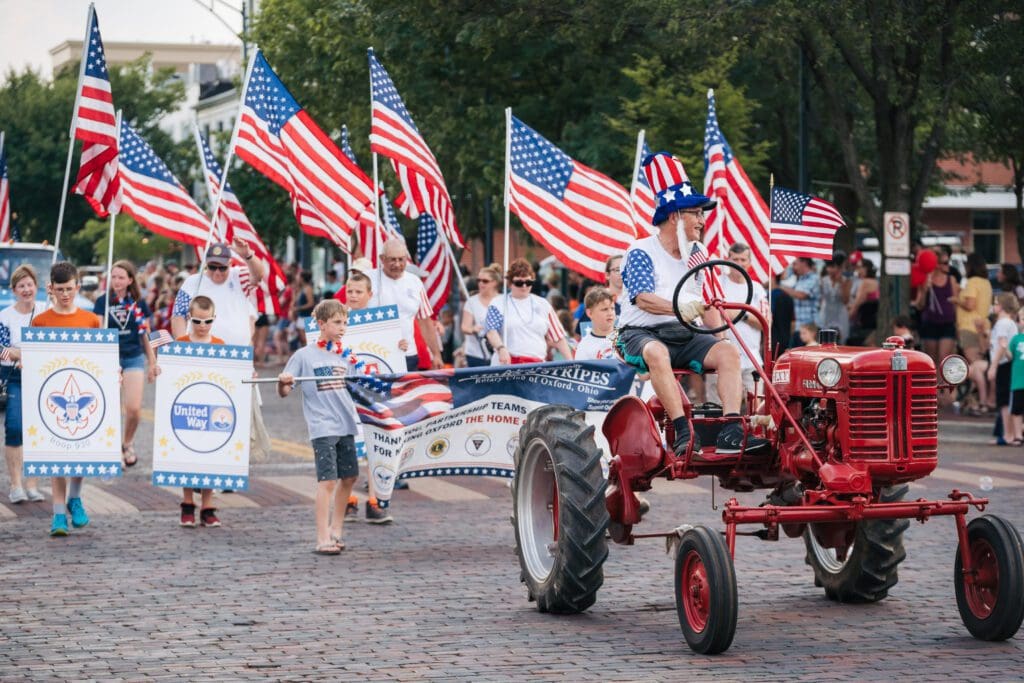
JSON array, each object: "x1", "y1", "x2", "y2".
[{"x1": 153, "y1": 342, "x2": 253, "y2": 490}]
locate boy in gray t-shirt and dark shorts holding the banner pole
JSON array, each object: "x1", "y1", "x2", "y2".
[{"x1": 278, "y1": 299, "x2": 361, "y2": 555}]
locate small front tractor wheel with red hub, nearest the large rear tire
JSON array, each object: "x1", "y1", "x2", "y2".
[{"x1": 676, "y1": 526, "x2": 737, "y2": 654}]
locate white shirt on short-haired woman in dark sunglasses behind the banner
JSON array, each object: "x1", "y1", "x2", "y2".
[{"x1": 483, "y1": 294, "x2": 565, "y2": 365}]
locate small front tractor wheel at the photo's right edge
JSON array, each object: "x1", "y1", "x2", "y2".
[{"x1": 953, "y1": 515, "x2": 1024, "y2": 640}]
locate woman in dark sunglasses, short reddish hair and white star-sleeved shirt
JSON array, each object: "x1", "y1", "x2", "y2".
[{"x1": 484, "y1": 258, "x2": 572, "y2": 366}]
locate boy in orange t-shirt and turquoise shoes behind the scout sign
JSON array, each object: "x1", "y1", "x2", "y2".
[{"x1": 32, "y1": 261, "x2": 101, "y2": 536}]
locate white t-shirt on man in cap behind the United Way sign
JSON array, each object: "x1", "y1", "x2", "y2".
[{"x1": 173, "y1": 266, "x2": 256, "y2": 346}]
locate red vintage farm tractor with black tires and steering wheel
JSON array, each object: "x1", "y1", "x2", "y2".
[{"x1": 513, "y1": 260, "x2": 1024, "y2": 653}]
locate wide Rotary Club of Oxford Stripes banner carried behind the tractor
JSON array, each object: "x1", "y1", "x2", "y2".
[{"x1": 348, "y1": 360, "x2": 634, "y2": 501}]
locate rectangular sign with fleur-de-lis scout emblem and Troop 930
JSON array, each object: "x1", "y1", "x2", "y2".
[{"x1": 22, "y1": 328, "x2": 121, "y2": 477}]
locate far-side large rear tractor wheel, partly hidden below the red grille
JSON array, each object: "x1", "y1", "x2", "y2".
[{"x1": 804, "y1": 484, "x2": 910, "y2": 602}]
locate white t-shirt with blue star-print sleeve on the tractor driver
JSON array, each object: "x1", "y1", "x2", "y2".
[{"x1": 618, "y1": 234, "x2": 708, "y2": 328}]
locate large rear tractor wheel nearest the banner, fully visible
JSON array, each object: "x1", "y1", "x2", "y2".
[{"x1": 512, "y1": 405, "x2": 608, "y2": 614}]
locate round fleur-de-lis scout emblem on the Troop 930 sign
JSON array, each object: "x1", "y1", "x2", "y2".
[{"x1": 39, "y1": 368, "x2": 106, "y2": 441}]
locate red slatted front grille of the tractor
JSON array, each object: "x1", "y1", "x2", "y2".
[{"x1": 849, "y1": 371, "x2": 939, "y2": 462}]
